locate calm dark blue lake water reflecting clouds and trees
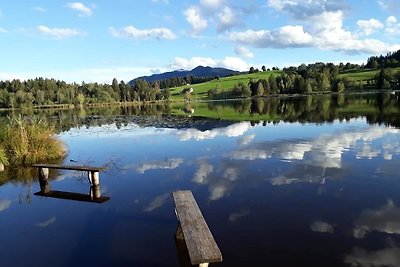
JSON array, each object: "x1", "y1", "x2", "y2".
[{"x1": 0, "y1": 95, "x2": 400, "y2": 267}]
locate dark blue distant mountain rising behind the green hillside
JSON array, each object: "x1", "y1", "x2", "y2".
[{"x1": 129, "y1": 66, "x2": 239, "y2": 86}]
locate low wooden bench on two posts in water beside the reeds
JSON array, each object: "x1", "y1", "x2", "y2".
[{"x1": 32, "y1": 164, "x2": 107, "y2": 185}]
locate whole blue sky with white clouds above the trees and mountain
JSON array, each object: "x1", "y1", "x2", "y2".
[{"x1": 0, "y1": 0, "x2": 400, "y2": 83}]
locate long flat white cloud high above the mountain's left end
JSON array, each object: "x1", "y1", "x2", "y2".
[{"x1": 109, "y1": 26, "x2": 176, "y2": 40}]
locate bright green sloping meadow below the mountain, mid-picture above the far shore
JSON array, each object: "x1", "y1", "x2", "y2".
[{"x1": 171, "y1": 71, "x2": 283, "y2": 101}]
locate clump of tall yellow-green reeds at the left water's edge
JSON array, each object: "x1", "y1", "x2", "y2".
[{"x1": 0, "y1": 117, "x2": 66, "y2": 165}]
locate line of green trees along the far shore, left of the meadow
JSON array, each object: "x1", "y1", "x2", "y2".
[{"x1": 0, "y1": 78, "x2": 170, "y2": 108}]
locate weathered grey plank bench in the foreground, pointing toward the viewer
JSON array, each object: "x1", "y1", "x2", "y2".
[{"x1": 172, "y1": 190, "x2": 222, "y2": 267}]
